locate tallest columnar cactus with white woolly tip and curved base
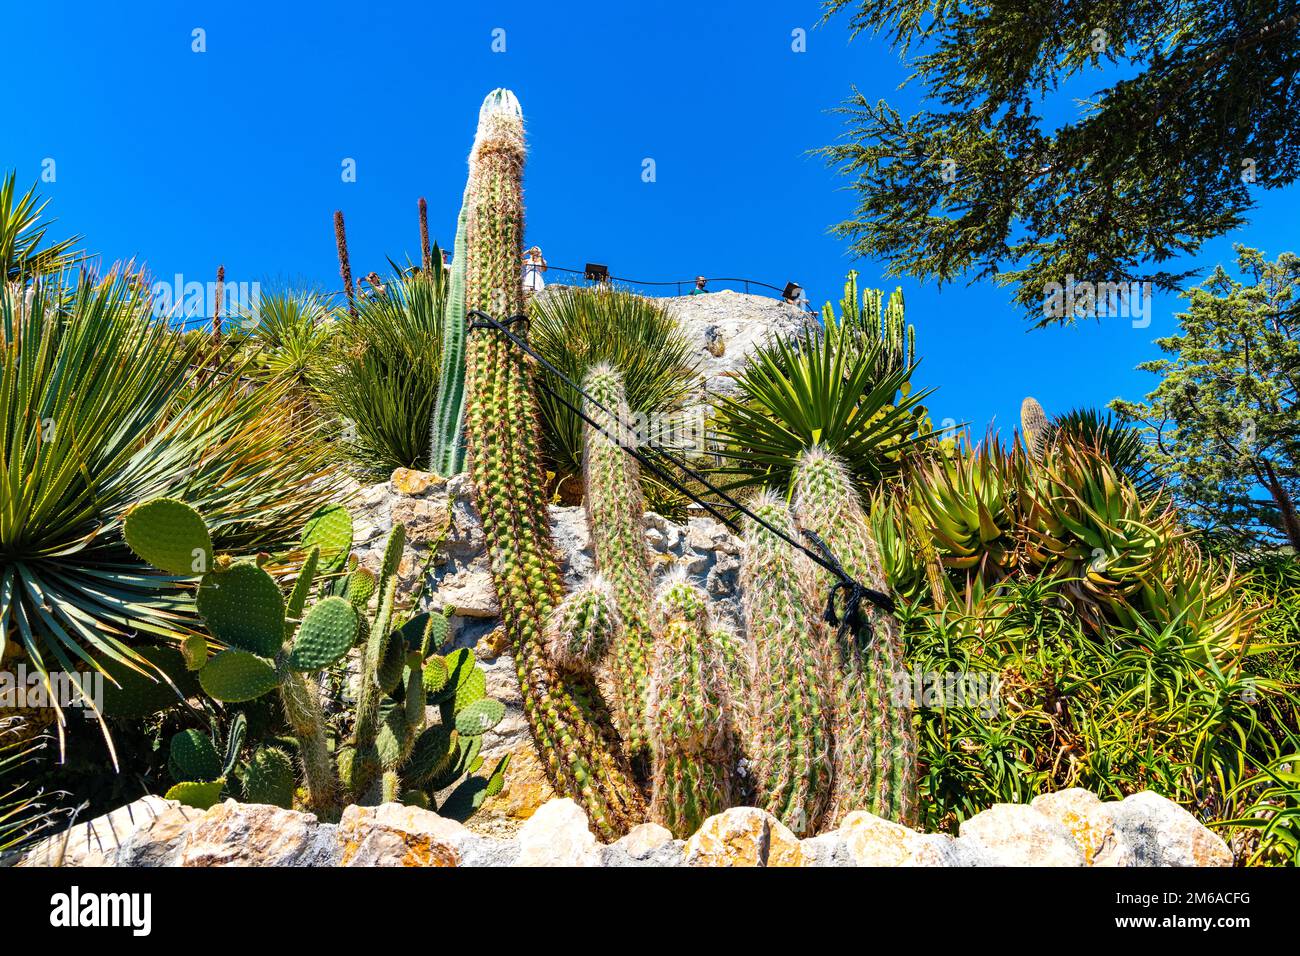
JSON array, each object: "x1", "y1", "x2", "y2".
[{"x1": 464, "y1": 90, "x2": 645, "y2": 835}]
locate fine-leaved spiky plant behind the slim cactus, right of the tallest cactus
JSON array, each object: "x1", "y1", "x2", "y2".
[{"x1": 529, "y1": 286, "x2": 699, "y2": 509}]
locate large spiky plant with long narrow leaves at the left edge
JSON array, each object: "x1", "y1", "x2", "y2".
[{"x1": 0, "y1": 273, "x2": 335, "y2": 738}]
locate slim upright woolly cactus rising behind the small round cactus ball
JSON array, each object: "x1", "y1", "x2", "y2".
[{"x1": 582, "y1": 363, "x2": 654, "y2": 758}]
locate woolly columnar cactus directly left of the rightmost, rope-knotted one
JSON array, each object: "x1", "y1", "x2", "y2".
[{"x1": 741, "y1": 492, "x2": 835, "y2": 836}]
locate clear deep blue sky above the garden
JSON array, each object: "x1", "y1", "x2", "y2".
[{"x1": 10, "y1": 0, "x2": 1300, "y2": 434}]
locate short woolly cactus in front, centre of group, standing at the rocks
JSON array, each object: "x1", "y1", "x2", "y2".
[{"x1": 649, "y1": 576, "x2": 738, "y2": 839}]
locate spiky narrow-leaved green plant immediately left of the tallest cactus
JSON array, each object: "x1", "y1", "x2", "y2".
[{"x1": 313, "y1": 268, "x2": 446, "y2": 476}]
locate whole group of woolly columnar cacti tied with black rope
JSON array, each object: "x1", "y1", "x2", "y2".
[{"x1": 436, "y1": 90, "x2": 914, "y2": 836}]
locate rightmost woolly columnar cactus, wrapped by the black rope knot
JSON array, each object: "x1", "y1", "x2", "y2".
[{"x1": 793, "y1": 447, "x2": 917, "y2": 826}]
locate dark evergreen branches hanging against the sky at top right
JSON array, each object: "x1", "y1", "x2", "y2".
[{"x1": 822, "y1": 0, "x2": 1300, "y2": 325}]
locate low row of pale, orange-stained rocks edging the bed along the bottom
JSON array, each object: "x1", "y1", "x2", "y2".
[{"x1": 20, "y1": 790, "x2": 1232, "y2": 868}]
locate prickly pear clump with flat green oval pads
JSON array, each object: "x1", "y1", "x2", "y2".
[{"x1": 125, "y1": 498, "x2": 507, "y2": 819}]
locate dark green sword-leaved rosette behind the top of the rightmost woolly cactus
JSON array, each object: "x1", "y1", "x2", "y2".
[{"x1": 714, "y1": 333, "x2": 932, "y2": 488}]
